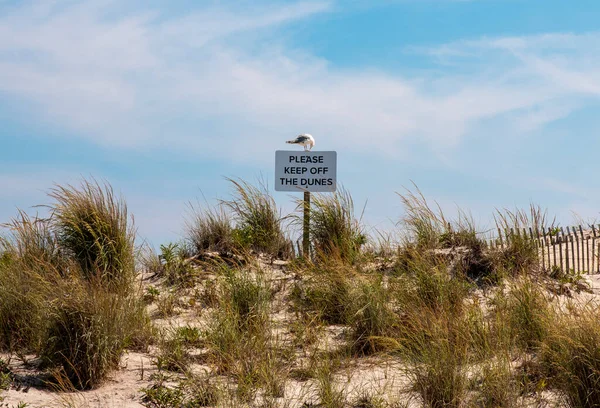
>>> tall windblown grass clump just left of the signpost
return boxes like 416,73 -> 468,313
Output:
222,179 -> 291,257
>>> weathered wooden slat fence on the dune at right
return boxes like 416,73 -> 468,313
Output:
487,225 -> 600,273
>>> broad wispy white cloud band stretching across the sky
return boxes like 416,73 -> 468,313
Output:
0,0 -> 600,163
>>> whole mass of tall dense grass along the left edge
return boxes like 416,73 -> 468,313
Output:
0,181 -> 152,389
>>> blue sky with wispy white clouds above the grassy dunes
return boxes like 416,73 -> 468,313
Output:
0,0 -> 600,245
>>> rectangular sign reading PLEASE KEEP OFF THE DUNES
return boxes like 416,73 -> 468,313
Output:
275,150 -> 337,193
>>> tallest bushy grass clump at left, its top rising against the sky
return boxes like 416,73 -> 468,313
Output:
50,180 -> 135,290
